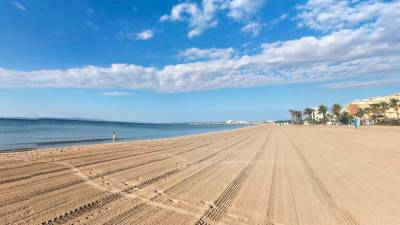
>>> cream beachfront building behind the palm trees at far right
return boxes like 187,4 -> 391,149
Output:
344,92 -> 400,119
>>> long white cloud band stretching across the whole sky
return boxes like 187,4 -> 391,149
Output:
0,0 -> 400,92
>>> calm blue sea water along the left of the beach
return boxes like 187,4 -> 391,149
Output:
0,119 -> 244,150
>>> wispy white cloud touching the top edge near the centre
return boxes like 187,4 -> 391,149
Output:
160,0 -> 264,38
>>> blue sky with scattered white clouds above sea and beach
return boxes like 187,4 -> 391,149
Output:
0,0 -> 400,122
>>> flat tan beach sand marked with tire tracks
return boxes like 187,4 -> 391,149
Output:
0,126 -> 400,225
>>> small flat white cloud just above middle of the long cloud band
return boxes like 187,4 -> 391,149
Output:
178,48 -> 235,61
